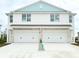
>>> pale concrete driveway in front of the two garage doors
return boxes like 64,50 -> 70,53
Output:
0,43 -> 79,58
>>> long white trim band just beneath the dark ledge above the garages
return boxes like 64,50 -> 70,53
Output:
9,26 -> 71,29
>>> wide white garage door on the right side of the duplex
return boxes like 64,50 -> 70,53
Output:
42,30 -> 68,42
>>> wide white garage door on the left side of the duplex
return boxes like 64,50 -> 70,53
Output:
14,30 -> 39,42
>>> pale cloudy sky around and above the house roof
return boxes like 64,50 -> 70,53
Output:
0,0 -> 79,36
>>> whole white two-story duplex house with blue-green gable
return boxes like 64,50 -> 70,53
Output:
7,1 -> 75,43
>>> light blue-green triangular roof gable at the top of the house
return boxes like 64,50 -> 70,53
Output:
15,1 -> 66,12
